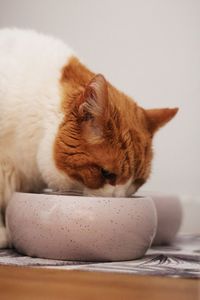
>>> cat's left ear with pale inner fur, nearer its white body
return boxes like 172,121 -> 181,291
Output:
78,74 -> 108,121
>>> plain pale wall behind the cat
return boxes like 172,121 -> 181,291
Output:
0,0 -> 200,195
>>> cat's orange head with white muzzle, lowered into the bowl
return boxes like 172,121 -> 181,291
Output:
54,58 -> 178,197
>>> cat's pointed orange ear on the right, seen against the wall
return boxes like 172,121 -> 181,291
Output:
145,108 -> 178,135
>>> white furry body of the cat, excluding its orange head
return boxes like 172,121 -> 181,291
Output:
0,29 -> 76,244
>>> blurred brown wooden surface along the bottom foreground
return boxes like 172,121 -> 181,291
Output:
0,266 -> 200,300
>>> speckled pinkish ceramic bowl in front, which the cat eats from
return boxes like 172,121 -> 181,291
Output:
6,193 -> 157,261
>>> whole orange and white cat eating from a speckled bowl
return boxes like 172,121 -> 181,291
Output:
0,29 -> 178,247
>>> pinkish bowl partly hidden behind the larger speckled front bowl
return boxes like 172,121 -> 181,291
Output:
140,192 -> 183,245
